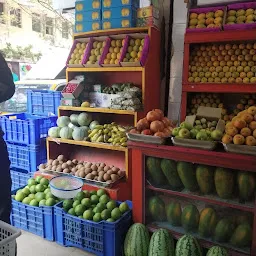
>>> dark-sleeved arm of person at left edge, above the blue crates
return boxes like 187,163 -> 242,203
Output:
0,53 -> 15,103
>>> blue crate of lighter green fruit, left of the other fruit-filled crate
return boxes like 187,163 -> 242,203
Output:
10,187 -> 54,241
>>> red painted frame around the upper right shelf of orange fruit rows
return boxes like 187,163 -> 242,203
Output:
181,29 -> 256,120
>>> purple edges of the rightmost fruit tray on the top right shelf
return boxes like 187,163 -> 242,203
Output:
223,2 -> 256,30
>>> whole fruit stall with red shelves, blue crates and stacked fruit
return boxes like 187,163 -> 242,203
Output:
1,0 -> 256,256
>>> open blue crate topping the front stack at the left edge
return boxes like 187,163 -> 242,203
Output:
0,113 -> 57,145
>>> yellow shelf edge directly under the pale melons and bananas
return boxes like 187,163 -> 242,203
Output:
47,137 -> 128,152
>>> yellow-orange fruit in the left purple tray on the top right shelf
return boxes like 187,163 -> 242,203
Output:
189,10 -> 224,28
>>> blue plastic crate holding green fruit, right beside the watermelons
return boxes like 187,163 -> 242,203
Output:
54,201 -> 132,256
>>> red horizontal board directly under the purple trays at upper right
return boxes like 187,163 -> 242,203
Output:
185,29 -> 256,44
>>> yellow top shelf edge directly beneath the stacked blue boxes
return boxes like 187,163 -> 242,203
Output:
74,27 -> 150,39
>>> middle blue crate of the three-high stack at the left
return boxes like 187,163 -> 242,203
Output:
6,140 -> 47,172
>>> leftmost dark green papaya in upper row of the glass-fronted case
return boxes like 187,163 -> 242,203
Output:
146,157 -> 166,185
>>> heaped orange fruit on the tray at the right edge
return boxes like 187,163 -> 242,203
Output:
222,106 -> 256,146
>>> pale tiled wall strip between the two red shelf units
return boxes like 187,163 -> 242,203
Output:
168,0 -> 187,120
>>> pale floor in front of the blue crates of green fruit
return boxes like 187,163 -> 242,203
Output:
17,231 -> 94,256
